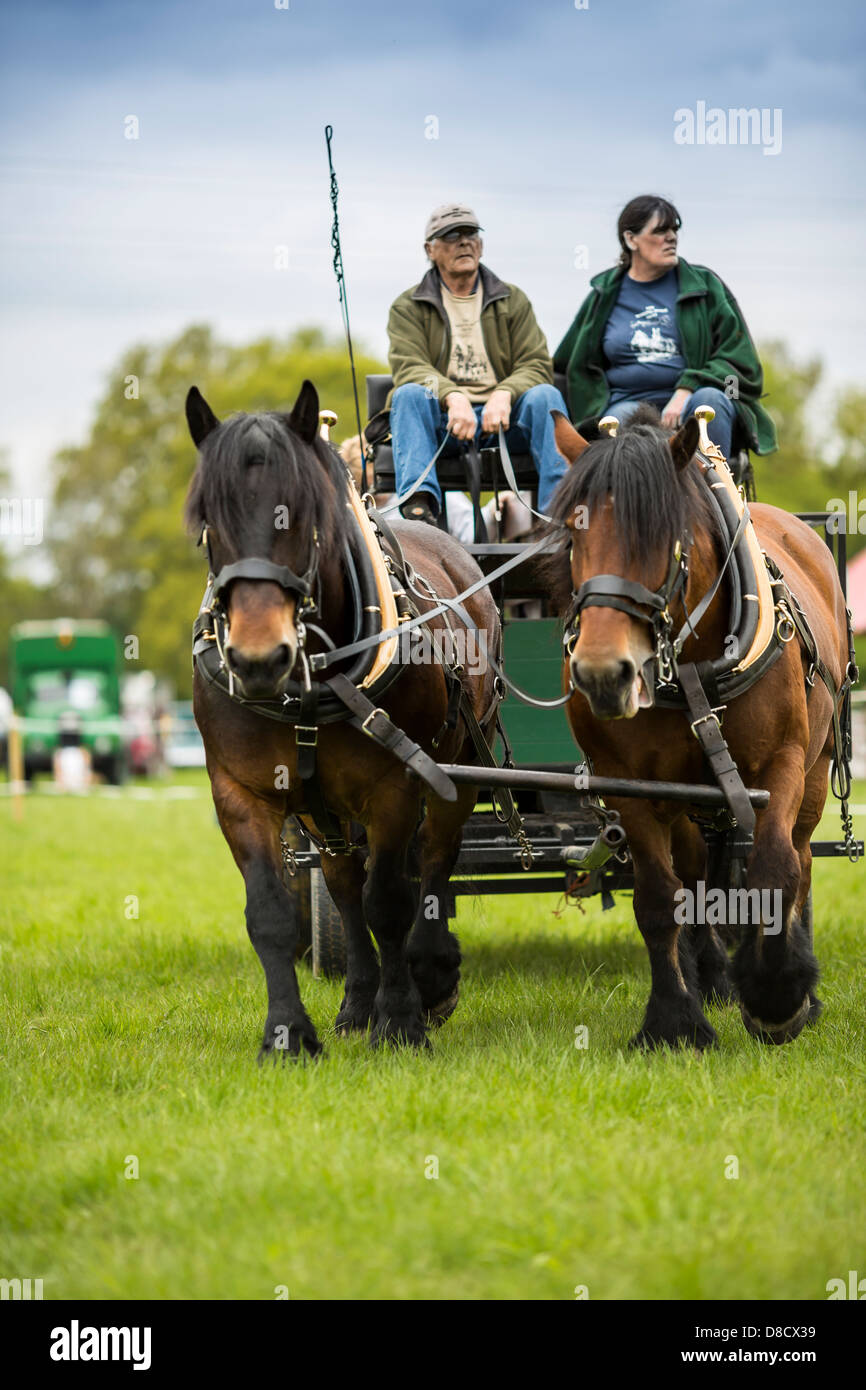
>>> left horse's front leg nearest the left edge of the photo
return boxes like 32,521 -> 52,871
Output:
211,770 -> 321,1062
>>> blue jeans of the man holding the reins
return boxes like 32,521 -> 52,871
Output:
391,382 -> 569,512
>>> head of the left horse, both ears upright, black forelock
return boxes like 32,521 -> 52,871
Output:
186,381 -> 345,699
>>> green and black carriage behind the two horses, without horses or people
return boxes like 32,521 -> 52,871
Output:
286,375 -> 862,976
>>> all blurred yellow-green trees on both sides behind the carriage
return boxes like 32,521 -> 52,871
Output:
0,325 -> 866,698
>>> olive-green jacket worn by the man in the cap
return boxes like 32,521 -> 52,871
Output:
388,265 -> 553,407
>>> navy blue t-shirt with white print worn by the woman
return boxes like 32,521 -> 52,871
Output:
602,267 -> 685,404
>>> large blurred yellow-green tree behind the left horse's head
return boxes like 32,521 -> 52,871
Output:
38,325 -> 384,695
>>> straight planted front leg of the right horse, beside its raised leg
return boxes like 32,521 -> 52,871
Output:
617,802 -> 717,1048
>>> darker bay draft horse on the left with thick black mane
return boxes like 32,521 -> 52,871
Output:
186,381 -> 499,1061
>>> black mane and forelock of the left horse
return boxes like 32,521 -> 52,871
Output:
185,410 -> 346,555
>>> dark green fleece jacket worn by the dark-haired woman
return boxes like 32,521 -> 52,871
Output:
553,260 -> 778,453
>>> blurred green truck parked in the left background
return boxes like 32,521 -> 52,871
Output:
10,619 -> 126,785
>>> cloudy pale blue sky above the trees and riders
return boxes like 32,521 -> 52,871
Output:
0,0 -> 866,511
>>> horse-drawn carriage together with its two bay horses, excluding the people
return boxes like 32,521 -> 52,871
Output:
188,378 -> 862,1055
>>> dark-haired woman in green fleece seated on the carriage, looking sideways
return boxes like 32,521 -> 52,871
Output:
553,196 -> 777,459
